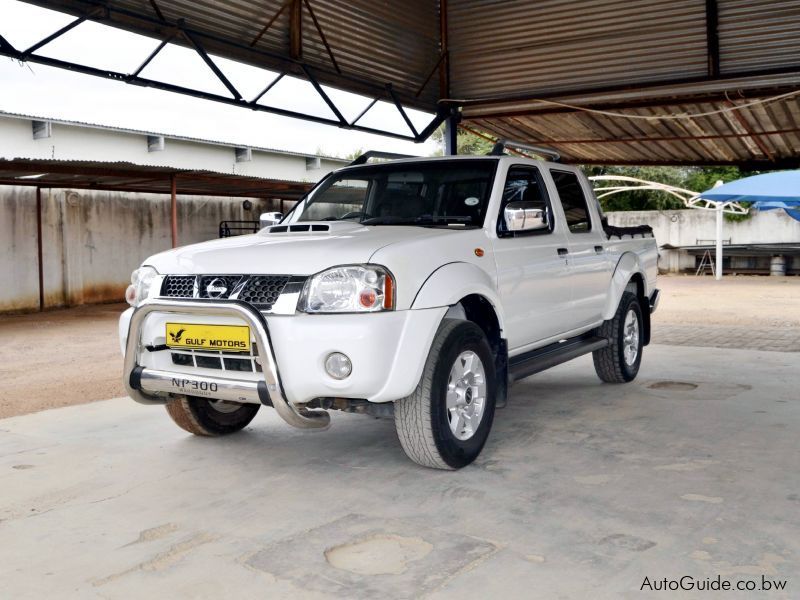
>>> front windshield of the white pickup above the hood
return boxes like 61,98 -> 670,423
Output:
296,160 -> 497,227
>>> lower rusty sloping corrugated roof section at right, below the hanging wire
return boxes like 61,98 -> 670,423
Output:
466,95 -> 800,168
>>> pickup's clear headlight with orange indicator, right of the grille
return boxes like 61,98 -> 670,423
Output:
298,265 -> 395,313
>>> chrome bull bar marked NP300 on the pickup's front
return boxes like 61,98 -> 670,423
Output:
123,298 -> 330,429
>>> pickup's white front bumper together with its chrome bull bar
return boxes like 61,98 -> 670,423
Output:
120,298 -> 447,428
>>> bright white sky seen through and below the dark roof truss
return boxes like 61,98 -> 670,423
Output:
0,0 -> 437,156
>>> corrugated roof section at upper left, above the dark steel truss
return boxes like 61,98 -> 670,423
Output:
23,0 -> 440,110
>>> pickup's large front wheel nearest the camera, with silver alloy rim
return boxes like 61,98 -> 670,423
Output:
394,319 -> 497,470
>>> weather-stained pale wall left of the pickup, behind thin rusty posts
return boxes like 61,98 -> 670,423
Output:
0,186 -> 276,312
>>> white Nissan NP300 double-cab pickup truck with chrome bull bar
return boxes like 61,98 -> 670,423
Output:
119,148 -> 658,469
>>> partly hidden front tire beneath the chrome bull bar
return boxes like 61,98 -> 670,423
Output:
166,396 -> 260,436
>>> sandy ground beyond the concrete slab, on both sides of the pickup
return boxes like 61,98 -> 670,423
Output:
0,276 -> 800,419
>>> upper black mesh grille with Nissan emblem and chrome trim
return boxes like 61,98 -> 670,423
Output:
161,275 -> 294,311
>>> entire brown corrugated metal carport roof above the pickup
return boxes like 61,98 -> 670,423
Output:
12,0 -> 800,168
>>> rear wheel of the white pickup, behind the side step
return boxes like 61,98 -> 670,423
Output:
592,292 -> 644,383
